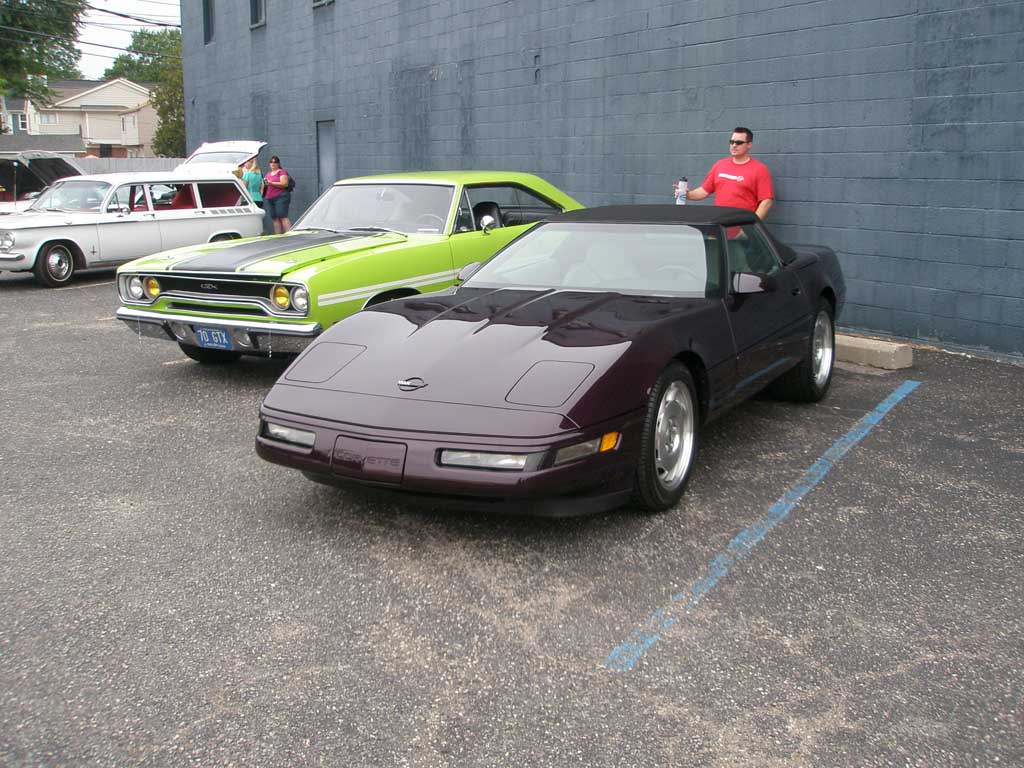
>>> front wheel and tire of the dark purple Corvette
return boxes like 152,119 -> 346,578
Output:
633,362 -> 700,512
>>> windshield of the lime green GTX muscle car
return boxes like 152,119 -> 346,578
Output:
295,183 -> 455,234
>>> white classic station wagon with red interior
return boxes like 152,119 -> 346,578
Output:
0,166 -> 263,288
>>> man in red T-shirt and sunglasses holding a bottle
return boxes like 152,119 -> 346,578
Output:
686,128 -> 775,219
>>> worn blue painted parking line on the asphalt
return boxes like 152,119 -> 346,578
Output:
603,380 -> 921,672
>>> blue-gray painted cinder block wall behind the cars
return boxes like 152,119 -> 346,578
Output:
182,0 -> 1024,354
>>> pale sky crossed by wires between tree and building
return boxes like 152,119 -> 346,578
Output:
78,0 -> 181,80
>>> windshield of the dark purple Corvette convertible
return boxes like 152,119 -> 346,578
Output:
465,222 -> 720,296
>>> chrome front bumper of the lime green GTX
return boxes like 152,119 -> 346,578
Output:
117,306 -> 324,356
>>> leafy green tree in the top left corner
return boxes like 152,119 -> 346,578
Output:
0,0 -> 87,103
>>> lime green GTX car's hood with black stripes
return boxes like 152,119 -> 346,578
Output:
118,229 -> 411,275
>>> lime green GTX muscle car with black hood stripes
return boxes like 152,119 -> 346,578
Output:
117,171 -> 582,364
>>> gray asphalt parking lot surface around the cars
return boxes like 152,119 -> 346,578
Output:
0,273 -> 1024,768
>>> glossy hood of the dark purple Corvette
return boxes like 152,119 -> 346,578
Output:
268,289 -> 708,426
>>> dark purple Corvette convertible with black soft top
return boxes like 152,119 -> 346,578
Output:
256,206 -> 846,515
